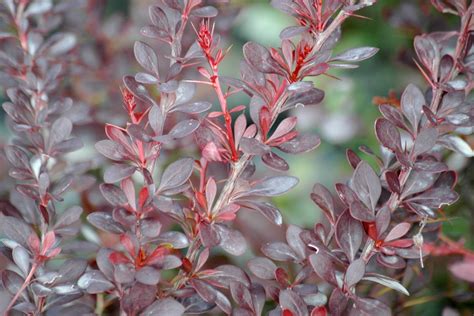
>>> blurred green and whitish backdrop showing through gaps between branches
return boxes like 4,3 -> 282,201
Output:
0,0 -> 474,315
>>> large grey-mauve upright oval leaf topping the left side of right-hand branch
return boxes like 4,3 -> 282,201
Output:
352,161 -> 382,210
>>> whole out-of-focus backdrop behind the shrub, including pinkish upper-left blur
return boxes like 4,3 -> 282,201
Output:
0,0 -> 474,315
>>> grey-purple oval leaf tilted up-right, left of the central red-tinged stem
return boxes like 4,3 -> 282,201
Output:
158,158 -> 194,192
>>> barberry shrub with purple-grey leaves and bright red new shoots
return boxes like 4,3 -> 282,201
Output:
0,0 -> 474,316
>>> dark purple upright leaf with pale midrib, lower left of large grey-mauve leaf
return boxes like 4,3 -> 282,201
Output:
336,211 -> 364,262
